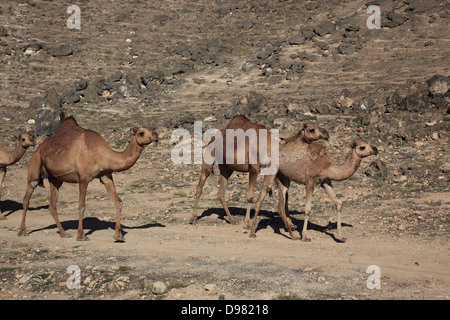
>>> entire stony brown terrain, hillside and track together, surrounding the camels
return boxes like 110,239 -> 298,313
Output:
0,0 -> 450,300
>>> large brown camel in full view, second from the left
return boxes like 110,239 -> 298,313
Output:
18,117 -> 158,241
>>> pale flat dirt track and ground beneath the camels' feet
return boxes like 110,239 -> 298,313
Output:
0,147 -> 450,299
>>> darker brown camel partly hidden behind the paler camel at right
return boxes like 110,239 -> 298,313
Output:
190,115 -> 328,229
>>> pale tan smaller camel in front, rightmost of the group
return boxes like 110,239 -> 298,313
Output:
250,140 -> 378,242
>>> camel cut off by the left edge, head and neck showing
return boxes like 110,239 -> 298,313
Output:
0,133 -> 35,220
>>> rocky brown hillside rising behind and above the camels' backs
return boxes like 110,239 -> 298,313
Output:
0,0 -> 450,188
